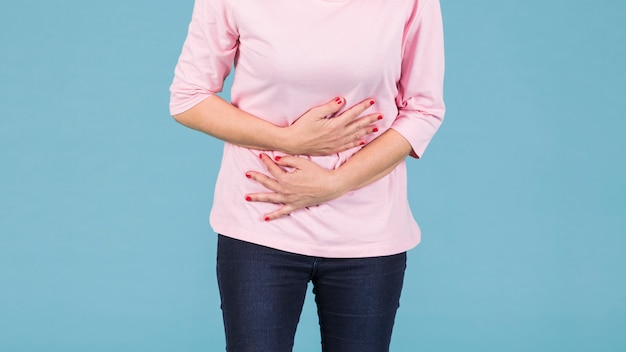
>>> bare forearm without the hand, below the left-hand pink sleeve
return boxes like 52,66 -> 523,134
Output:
174,95 -> 289,153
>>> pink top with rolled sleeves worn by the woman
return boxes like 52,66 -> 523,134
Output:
170,0 -> 445,258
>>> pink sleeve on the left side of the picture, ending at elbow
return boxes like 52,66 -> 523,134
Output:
170,0 -> 239,115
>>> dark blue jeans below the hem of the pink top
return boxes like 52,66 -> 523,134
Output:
217,235 -> 406,352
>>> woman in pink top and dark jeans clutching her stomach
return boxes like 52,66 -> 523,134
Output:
170,0 -> 444,352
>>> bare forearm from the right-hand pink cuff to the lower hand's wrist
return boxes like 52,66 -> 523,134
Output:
334,129 -> 412,193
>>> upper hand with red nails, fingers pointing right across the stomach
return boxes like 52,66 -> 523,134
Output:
285,97 -> 383,156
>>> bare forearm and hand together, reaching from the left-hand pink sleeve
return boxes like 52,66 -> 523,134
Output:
174,95 -> 383,156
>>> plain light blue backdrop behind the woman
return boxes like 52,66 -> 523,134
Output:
0,0 -> 626,352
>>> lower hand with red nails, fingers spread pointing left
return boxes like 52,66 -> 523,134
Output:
246,153 -> 346,221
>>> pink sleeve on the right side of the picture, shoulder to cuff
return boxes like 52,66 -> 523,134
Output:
391,0 -> 445,158
